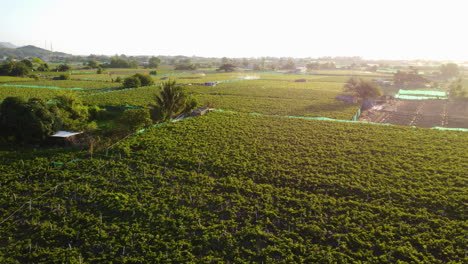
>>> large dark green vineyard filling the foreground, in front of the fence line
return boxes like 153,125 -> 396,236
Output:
0,112 -> 468,263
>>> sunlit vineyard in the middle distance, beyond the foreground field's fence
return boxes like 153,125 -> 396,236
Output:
0,73 -> 359,120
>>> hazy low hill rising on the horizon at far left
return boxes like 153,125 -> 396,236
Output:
0,42 -> 73,59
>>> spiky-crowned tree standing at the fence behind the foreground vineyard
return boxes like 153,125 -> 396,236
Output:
151,81 -> 197,122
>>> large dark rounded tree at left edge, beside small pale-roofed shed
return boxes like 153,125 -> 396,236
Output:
0,97 -> 62,143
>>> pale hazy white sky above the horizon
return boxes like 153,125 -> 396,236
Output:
0,0 -> 468,60
